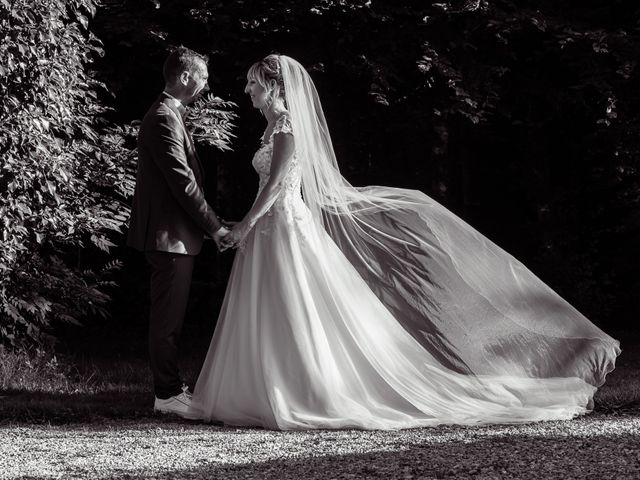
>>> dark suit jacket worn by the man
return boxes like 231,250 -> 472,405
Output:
127,93 -> 220,255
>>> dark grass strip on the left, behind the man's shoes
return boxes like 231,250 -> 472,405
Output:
0,356 -> 200,425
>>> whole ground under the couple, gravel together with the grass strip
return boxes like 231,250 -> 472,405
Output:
0,334 -> 640,480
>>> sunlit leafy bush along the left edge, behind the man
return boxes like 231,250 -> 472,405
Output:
0,0 -> 134,344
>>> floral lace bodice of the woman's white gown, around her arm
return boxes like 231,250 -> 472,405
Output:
251,114 -> 302,212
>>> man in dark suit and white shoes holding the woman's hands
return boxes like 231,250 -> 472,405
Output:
127,47 -> 228,418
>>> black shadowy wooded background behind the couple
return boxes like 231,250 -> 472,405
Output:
60,0 -> 640,355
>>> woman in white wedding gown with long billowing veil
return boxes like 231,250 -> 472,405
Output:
191,55 -> 620,430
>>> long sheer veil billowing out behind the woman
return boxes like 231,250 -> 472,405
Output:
279,55 -> 620,386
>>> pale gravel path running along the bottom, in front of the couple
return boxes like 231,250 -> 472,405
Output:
0,414 -> 640,480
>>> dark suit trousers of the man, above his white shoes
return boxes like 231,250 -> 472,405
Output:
145,251 -> 194,399
